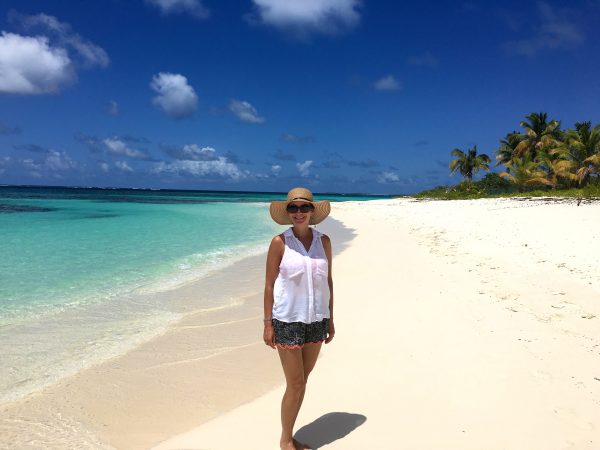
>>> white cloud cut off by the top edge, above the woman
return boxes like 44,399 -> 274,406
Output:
250,0 -> 362,37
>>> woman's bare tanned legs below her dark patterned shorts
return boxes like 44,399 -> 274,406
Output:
278,343 -> 321,450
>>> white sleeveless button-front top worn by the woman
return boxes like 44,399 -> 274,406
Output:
273,228 -> 330,323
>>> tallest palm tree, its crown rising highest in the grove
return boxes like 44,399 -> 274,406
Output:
515,112 -> 560,161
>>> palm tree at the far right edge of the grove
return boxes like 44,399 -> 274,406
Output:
565,122 -> 600,187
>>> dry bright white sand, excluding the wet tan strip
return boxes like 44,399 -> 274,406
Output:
154,199 -> 600,450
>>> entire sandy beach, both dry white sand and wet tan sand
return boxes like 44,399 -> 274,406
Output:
0,199 -> 600,450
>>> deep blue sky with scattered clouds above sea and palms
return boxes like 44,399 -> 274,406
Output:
0,0 -> 600,193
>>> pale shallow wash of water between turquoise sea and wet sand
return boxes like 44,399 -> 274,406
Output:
0,234 -> 276,407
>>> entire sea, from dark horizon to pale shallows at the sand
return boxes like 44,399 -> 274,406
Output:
0,186 -> 384,402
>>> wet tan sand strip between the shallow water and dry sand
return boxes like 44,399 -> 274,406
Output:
0,214 -> 351,449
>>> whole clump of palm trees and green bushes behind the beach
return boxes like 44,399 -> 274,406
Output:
417,112 -> 600,200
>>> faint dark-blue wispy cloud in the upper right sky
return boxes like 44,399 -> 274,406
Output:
504,1 -> 585,56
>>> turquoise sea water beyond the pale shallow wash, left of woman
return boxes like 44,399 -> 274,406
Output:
0,193 -> 276,324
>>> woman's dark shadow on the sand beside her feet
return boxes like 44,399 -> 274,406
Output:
294,412 -> 367,450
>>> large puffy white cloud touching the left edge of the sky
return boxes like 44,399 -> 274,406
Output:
0,31 -> 76,95
